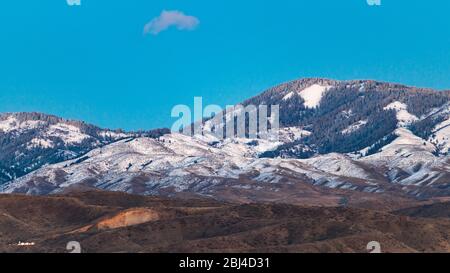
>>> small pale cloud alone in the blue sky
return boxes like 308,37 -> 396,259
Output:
144,10 -> 200,35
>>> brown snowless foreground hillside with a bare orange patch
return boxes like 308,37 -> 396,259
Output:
0,191 -> 450,253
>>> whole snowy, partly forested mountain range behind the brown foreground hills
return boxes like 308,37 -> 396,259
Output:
0,78 -> 450,209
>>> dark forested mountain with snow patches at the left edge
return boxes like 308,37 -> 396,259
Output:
0,113 -> 149,184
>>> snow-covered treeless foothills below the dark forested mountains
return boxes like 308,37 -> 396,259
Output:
0,122 -> 448,198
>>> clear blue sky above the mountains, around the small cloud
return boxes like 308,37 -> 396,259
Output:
0,0 -> 450,130
